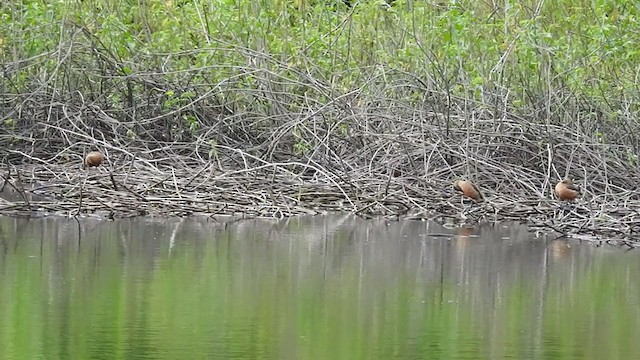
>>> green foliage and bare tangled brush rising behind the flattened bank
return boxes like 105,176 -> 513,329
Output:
0,0 -> 640,238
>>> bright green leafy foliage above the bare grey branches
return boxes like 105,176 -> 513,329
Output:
0,0 -> 640,136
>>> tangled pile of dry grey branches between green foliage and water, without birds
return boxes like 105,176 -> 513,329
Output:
0,107 -> 640,246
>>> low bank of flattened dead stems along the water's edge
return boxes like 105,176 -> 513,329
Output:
0,150 -> 640,248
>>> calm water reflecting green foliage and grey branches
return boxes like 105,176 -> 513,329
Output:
0,216 -> 640,359
